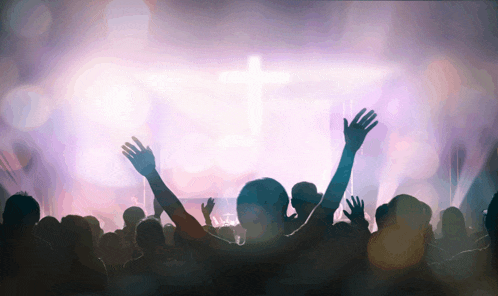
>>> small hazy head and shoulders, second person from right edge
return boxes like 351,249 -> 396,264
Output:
436,207 -> 474,257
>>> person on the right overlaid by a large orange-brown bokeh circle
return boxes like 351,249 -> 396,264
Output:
368,194 -> 449,295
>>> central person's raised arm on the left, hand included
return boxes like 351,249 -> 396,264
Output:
121,137 -> 206,238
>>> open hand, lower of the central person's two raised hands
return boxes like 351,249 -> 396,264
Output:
121,137 -> 156,177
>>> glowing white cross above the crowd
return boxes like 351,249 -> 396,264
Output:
220,56 -> 290,135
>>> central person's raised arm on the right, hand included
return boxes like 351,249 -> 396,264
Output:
322,109 -> 378,217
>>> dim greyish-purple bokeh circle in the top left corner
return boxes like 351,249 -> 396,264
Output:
3,0 -> 52,38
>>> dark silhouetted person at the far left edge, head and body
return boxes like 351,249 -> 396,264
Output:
0,192 -> 58,295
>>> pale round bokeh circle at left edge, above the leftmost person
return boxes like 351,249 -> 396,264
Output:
0,85 -> 53,131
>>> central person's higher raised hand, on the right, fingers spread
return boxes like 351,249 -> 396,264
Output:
344,109 -> 378,152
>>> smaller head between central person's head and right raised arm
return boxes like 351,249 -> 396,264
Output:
291,182 -> 322,219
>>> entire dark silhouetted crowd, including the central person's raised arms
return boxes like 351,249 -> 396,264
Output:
0,109 -> 498,296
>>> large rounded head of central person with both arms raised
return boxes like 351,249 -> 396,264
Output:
237,178 -> 289,242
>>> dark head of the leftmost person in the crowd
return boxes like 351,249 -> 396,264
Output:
2,192 -> 40,233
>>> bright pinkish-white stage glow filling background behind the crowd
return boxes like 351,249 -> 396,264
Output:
0,0 -> 498,229
